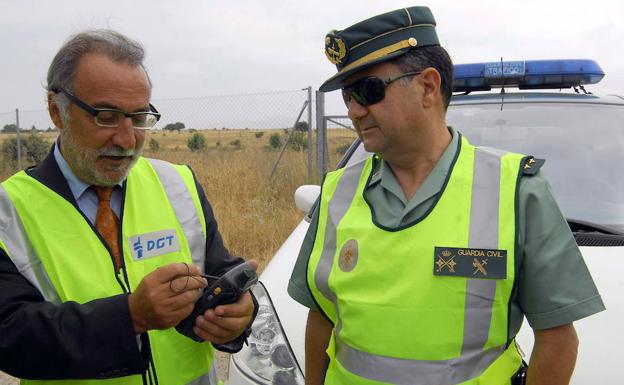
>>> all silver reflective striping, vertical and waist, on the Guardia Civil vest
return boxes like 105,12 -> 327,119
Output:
315,148 -> 505,385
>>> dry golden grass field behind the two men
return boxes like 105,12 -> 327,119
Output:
0,130 -> 355,268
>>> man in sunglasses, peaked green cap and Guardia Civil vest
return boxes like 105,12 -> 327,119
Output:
288,7 -> 604,385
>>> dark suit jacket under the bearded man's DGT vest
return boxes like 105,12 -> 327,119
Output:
0,152 -> 244,379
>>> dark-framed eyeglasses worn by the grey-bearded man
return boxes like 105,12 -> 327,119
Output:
52,88 -> 160,130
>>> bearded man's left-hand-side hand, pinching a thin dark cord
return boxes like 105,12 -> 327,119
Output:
128,263 -> 208,334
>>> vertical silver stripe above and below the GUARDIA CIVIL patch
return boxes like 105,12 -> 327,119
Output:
462,147 -> 505,356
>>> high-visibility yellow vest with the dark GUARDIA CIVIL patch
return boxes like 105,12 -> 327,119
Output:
307,138 -> 524,385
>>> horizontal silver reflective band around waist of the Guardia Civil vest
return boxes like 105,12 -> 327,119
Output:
334,335 -> 505,385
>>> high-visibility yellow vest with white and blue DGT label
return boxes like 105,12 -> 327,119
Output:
0,158 -> 214,385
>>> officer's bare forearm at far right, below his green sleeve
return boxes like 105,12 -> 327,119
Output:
527,323 -> 578,385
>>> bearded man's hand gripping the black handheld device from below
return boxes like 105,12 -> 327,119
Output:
193,259 -> 258,344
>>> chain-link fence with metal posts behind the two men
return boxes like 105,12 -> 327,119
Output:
0,87 -> 357,180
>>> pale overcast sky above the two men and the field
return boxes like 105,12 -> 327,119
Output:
0,0 -> 624,127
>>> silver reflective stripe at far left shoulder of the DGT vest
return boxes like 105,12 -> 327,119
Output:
0,186 -> 61,304
